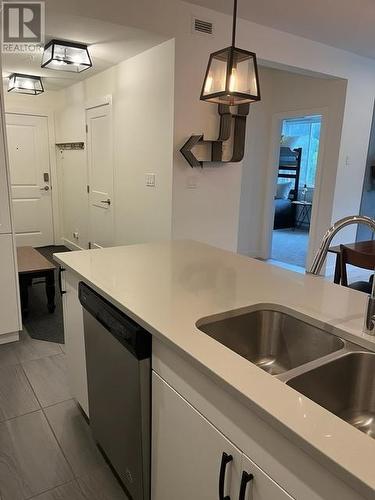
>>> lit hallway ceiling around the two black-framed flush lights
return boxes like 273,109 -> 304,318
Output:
2,14 -> 163,90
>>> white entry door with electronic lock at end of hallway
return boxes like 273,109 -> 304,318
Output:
6,113 -> 54,247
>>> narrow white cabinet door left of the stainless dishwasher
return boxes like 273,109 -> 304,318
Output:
62,271 -> 89,416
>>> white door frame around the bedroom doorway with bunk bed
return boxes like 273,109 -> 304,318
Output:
260,107 -> 330,268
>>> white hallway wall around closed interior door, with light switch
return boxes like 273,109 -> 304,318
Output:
56,41 -> 174,248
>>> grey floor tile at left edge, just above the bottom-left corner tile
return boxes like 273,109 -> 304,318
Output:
0,365 -> 40,421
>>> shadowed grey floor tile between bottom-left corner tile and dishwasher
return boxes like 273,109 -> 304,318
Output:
44,400 -> 105,476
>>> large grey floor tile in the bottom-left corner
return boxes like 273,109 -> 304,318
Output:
0,411 -> 73,500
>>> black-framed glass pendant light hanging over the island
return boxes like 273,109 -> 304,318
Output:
200,0 -> 260,106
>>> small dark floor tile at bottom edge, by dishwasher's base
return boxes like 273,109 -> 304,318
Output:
77,466 -> 128,500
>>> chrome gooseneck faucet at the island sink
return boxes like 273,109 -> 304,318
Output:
307,215 -> 375,335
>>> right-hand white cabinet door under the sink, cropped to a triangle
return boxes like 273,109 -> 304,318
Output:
239,455 -> 293,500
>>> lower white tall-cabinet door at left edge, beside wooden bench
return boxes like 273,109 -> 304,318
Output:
0,234 -> 20,336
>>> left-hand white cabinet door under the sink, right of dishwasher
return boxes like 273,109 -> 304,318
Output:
152,372 -> 242,500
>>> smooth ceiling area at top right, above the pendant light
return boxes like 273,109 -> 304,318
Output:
189,0 -> 375,59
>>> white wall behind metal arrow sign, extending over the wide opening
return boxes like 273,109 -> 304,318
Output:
9,0 -> 375,254
